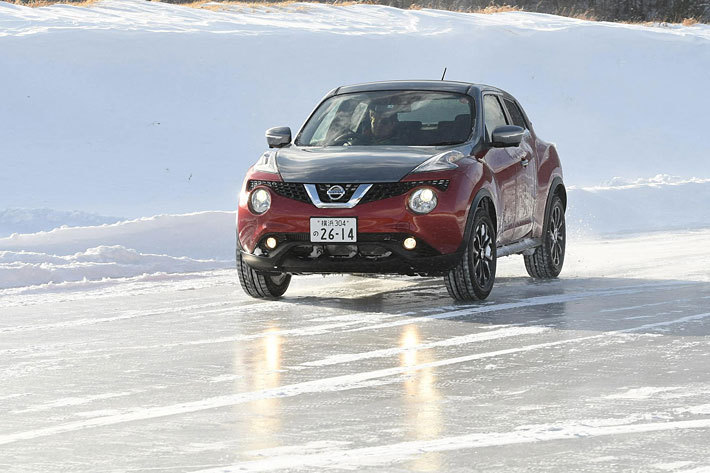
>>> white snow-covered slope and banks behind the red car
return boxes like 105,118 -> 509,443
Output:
0,0 -> 710,288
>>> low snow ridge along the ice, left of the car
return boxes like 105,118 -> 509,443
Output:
0,212 -> 236,289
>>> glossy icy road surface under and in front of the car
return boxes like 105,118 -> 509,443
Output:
0,233 -> 710,472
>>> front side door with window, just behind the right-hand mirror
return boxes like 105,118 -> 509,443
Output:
483,94 -> 520,245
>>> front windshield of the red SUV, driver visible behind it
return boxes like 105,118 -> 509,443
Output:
296,91 -> 474,146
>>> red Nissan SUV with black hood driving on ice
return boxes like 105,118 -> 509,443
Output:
237,81 -> 567,301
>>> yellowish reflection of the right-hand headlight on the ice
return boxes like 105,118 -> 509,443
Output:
400,325 -> 443,471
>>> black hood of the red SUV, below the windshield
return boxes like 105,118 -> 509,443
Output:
276,146 -> 442,184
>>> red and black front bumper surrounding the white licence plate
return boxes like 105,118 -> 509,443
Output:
237,172 -> 473,275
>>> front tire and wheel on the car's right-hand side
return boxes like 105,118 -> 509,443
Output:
444,207 -> 496,302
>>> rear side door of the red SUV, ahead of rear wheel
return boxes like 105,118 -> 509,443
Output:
502,97 -> 537,241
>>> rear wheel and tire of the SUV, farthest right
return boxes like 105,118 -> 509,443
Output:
523,195 -> 567,279
